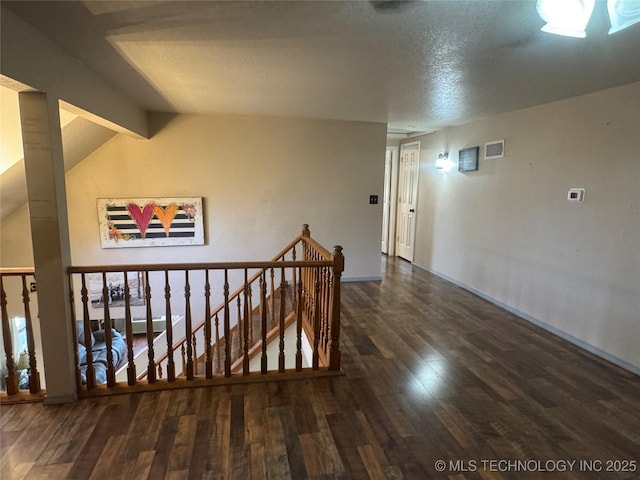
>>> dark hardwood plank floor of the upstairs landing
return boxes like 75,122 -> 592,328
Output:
0,258 -> 640,480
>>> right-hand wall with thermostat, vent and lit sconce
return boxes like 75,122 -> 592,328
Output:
408,83 -> 640,371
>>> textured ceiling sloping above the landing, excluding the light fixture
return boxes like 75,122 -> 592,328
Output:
3,1 -> 640,135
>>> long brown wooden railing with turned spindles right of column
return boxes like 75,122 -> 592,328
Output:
69,225 -> 344,395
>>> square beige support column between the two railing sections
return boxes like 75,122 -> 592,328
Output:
19,92 -> 77,403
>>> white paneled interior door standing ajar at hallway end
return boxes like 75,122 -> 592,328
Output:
396,142 -> 420,262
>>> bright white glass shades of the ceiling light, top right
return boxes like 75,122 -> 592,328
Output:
536,0 -> 640,38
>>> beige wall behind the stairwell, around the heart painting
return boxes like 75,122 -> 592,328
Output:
66,115 -> 386,278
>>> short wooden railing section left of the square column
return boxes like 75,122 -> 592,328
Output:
0,267 -> 44,403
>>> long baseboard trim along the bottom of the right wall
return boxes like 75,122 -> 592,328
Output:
413,263 -> 640,376
